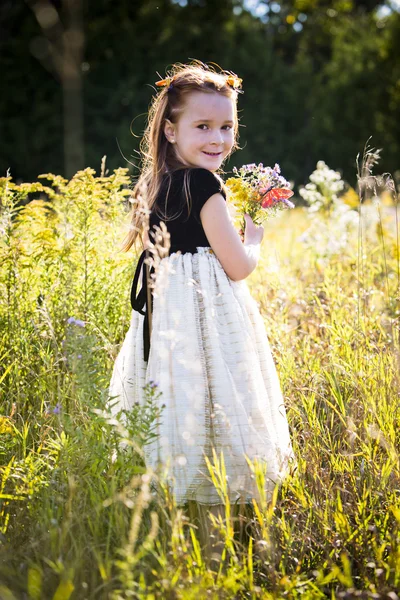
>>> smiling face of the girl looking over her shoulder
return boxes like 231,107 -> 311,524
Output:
164,92 -> 236,171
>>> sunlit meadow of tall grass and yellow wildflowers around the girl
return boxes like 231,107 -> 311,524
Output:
0,161 -> 400,600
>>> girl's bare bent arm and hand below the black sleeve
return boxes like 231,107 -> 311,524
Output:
200,194 -> 264,281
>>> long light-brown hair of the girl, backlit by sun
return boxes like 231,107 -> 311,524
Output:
122,61 -> 241,251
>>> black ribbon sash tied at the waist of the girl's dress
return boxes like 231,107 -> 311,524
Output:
131,246 -> 202,362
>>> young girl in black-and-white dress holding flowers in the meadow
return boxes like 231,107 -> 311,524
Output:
109,62 -> 293,556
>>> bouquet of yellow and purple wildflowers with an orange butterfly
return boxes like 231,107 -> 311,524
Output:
226,163 -> 294,232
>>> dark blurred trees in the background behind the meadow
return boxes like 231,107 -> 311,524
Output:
0,0 -> 400,185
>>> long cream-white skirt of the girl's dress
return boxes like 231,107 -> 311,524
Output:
109,246 -> 295,505
